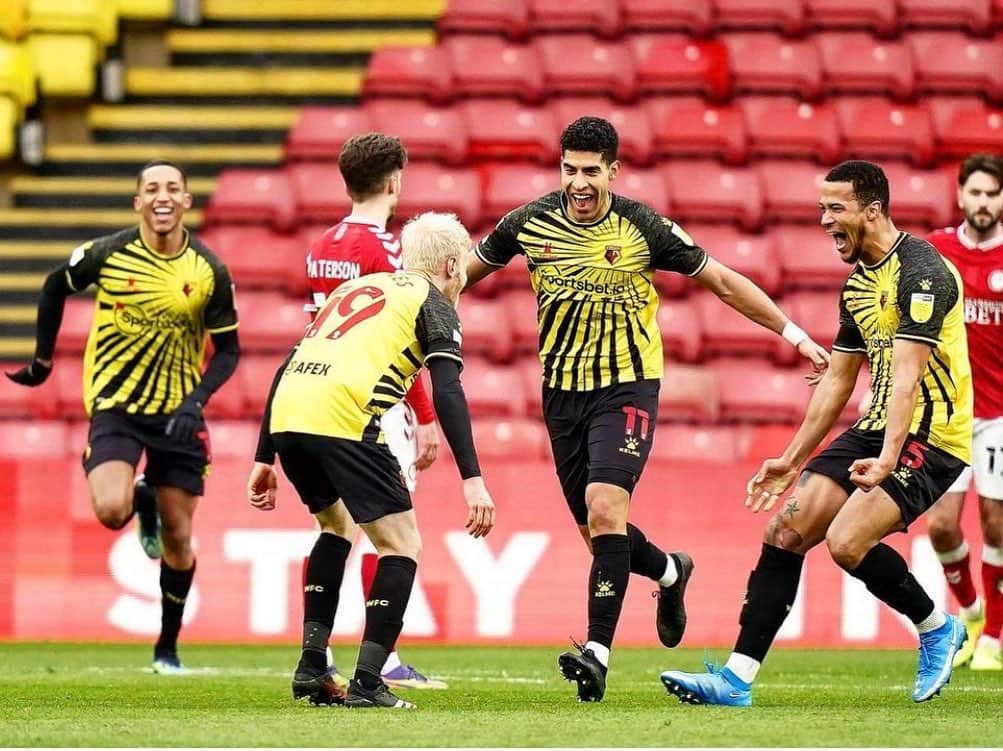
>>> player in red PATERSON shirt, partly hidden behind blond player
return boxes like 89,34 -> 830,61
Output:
303,133 -> 446,689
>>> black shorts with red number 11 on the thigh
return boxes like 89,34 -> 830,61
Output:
544,379 -> 660,525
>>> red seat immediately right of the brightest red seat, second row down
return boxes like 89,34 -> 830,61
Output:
724,34 -> 822,99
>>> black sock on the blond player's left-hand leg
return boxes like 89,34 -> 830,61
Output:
300,532 -> 352,671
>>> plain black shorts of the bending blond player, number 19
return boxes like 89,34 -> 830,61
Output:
272,432 -> 412,524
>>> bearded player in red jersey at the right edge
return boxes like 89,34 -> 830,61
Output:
927,153 -> 1003,670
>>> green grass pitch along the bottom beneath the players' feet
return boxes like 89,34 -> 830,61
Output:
0,644 -> 1003,747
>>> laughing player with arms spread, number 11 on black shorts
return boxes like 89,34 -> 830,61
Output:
467,117 -> 828,701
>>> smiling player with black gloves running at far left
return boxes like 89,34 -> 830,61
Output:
7,160 -> 240,674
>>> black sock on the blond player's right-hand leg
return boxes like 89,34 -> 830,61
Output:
355,555 -> 418,688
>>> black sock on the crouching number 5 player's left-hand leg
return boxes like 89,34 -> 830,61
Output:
735,542 -> 804,663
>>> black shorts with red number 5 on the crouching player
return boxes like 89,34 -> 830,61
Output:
804,428 -> 968,531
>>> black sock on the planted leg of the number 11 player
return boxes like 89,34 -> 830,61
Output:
588,534 -> 630,647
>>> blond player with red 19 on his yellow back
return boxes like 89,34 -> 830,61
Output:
248,214 -> 494,709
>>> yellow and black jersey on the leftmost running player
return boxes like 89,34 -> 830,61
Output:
66,228 -> 237,415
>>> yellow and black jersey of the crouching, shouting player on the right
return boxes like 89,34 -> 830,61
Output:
832,233 -> 973,464
